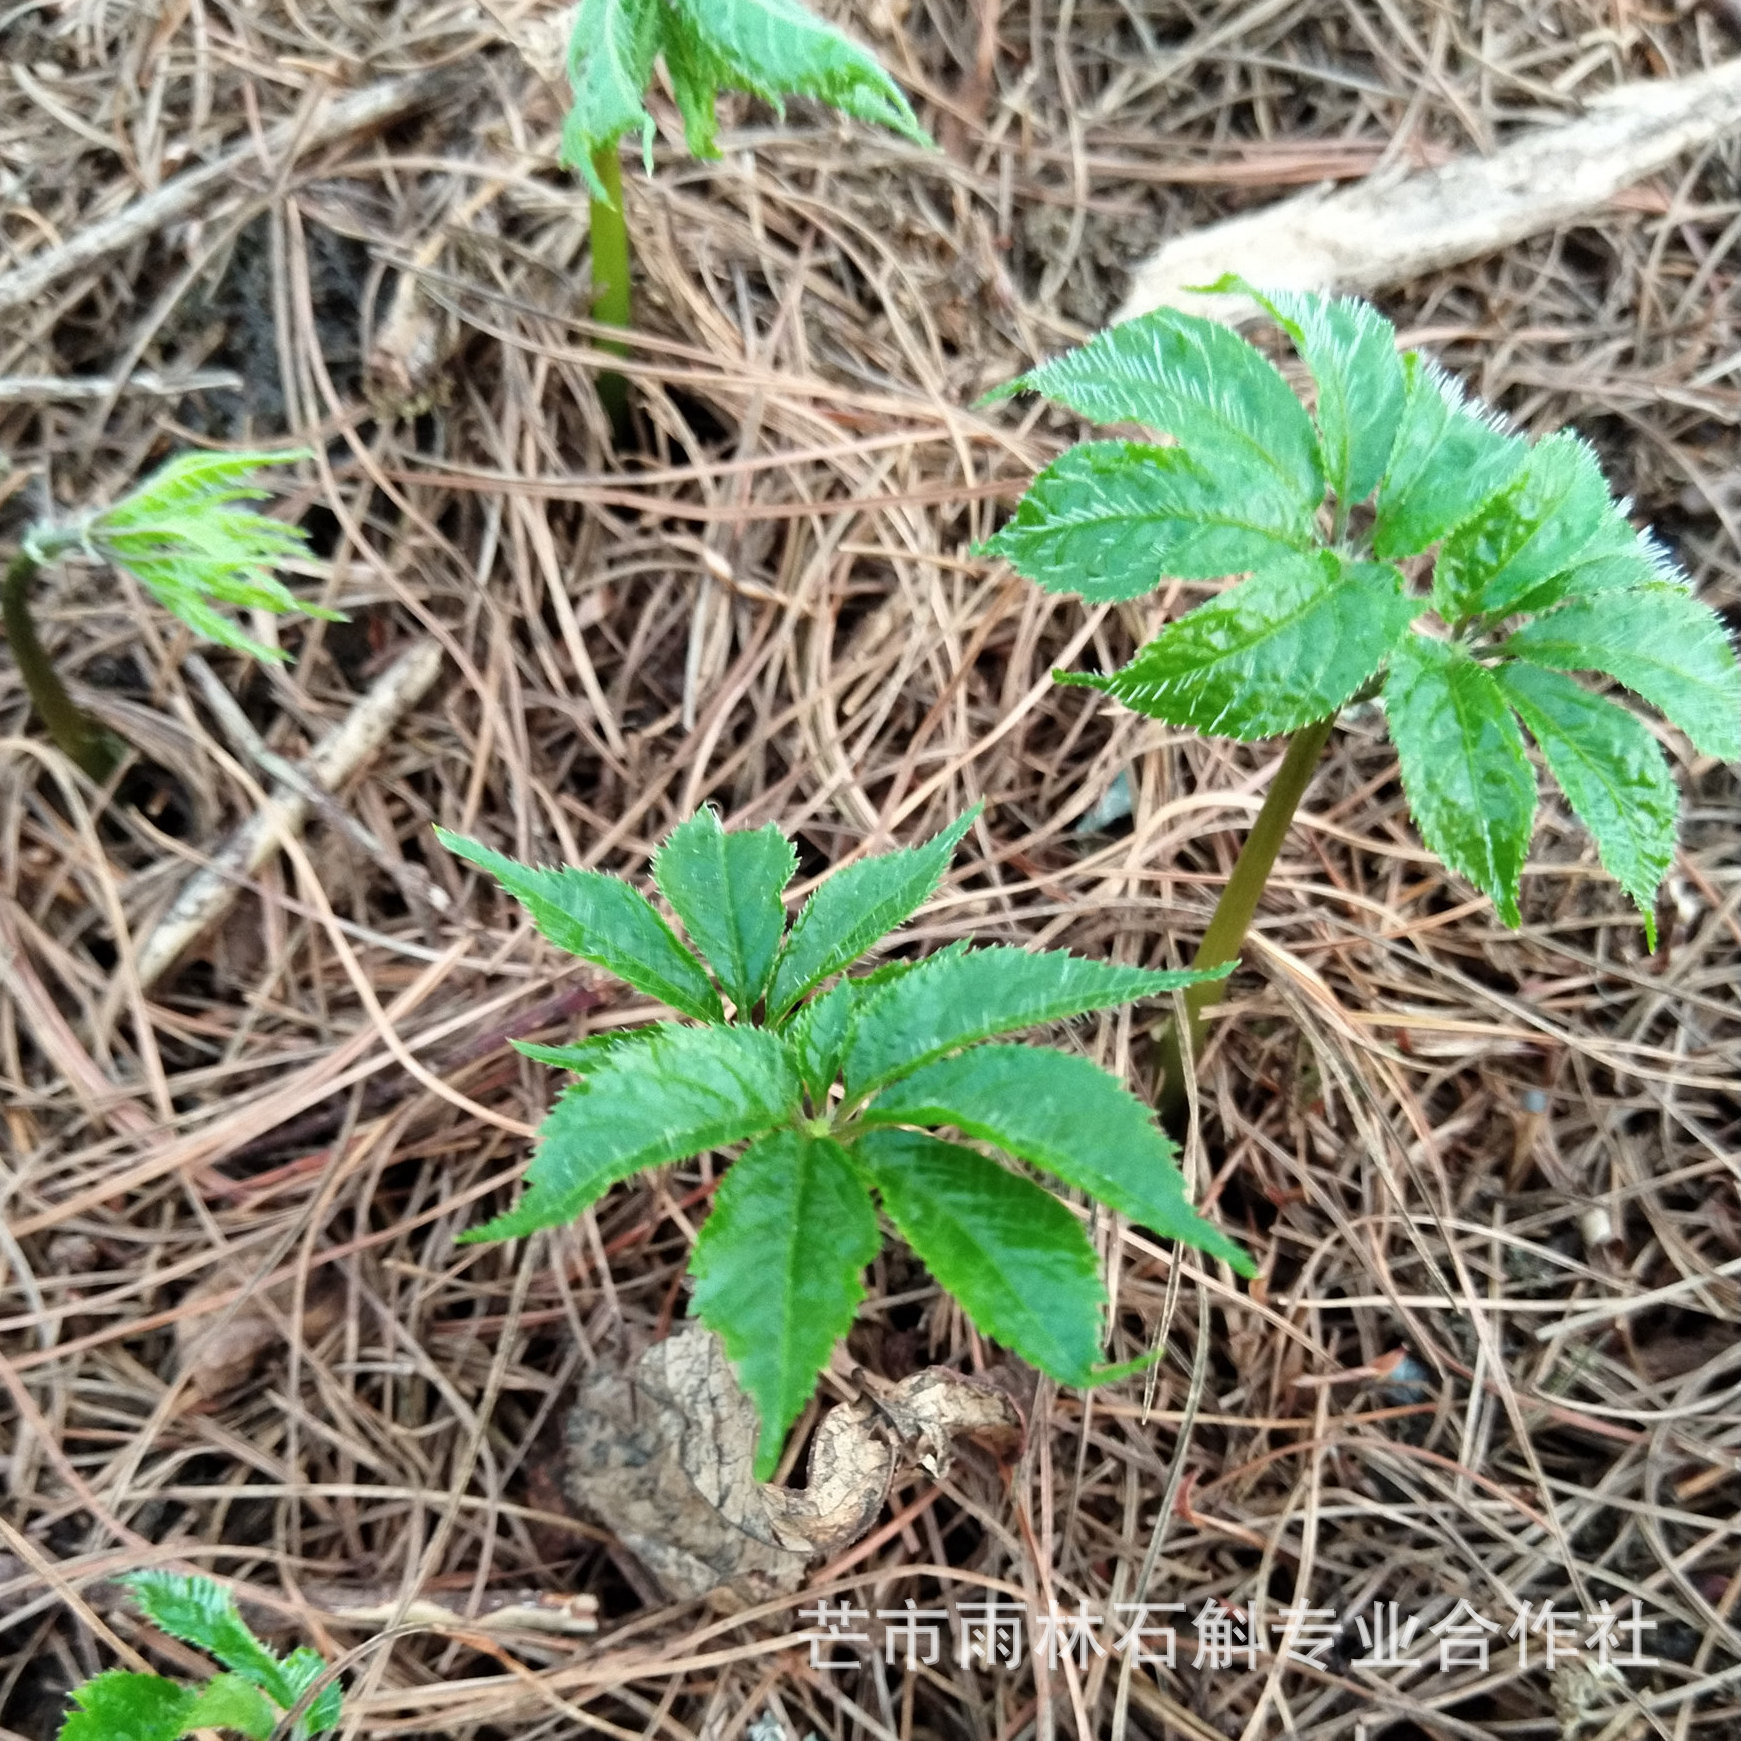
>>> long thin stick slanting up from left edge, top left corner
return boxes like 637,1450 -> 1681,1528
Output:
0,68 -> 463,315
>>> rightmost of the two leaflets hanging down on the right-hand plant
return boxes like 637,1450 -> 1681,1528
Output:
1494,660 -> 1680,949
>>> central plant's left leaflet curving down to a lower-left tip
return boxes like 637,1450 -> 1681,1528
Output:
460,1022 -> 799,1243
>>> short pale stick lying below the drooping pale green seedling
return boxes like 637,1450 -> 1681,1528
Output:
139,641 -> 440,985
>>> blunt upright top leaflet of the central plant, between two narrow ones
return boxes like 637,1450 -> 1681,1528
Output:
653,806 -> 797,1020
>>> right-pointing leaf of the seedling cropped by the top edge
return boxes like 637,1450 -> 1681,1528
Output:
667,0 -> 931,146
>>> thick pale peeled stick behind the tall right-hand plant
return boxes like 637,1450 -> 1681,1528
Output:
1118,59 -> 1741,322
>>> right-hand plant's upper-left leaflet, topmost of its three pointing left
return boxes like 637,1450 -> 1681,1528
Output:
987,308 -> 1323,514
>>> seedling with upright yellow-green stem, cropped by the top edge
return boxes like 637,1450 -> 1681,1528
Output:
561,0 -> 931,434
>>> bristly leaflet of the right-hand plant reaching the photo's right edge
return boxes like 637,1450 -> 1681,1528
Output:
1501,587 -> 1741,761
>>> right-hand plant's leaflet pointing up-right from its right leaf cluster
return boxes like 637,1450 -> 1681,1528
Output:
1433,430 -> 1610,623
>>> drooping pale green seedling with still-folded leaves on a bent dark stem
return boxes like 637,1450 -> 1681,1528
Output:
3,453 -> 330,783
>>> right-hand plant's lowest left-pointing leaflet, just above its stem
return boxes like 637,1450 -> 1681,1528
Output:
1055,550 -> 1419,742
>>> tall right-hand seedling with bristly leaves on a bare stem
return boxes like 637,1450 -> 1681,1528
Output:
984,277 -> 1741,1130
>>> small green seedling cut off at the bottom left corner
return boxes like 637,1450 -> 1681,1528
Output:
59,1572 -> 343,1741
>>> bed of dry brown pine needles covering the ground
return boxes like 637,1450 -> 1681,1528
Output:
0,0 -> 1741,1741
